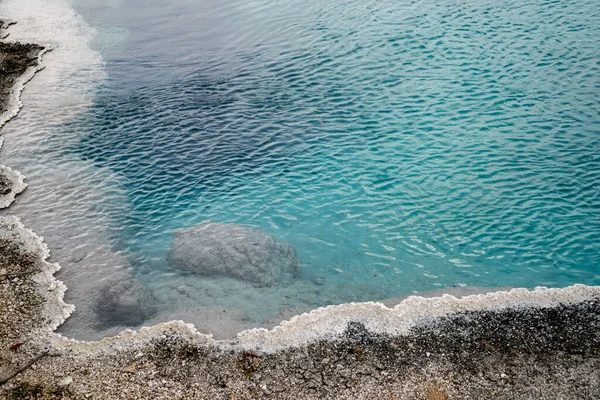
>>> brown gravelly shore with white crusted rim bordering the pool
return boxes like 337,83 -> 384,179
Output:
0,16 -> 600,400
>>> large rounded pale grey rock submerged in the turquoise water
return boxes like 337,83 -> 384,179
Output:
168,222 -> 300,286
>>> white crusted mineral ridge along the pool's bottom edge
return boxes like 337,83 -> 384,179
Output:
44,285 -> 600,353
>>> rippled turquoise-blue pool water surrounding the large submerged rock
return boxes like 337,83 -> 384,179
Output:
1,0 -> 600,338
